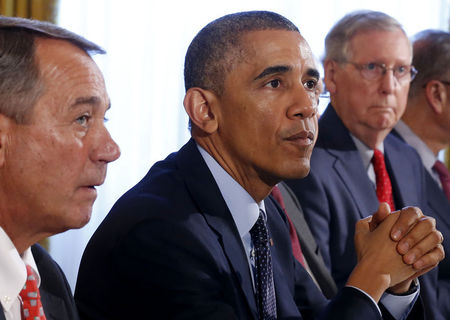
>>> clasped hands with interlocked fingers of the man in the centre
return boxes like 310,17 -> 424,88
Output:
347,203 -> 445,302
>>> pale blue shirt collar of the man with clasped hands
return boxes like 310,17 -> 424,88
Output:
197,144 -> 265,238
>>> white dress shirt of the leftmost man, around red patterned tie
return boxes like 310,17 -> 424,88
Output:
0,227 -> 41,320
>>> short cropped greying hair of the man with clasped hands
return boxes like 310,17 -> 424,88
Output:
184,11 -> 299,95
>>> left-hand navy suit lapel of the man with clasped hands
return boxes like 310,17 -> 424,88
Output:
177,139 -> 257,317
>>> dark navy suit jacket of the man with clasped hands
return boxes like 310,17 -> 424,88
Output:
75,140 -> 379,320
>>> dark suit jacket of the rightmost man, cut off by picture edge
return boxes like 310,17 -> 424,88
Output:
392,130 -> 450,319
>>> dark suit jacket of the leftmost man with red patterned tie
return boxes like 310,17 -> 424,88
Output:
0,244 -> 79,320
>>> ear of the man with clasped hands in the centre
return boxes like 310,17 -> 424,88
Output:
183,87 -> 218,134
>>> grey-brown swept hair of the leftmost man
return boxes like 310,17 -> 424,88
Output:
0,16 -> 105,123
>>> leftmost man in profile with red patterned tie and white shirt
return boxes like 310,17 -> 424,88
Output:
0,17 -> 119,320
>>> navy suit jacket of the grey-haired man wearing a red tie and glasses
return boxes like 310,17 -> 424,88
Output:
287,105 -> 439,319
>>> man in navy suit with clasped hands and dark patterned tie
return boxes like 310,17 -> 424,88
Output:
75,11 -> 443,319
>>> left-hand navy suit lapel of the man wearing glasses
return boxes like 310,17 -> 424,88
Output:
318,105 -> 378,218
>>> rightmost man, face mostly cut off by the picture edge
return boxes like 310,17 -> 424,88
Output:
393,30 -> 450,318
